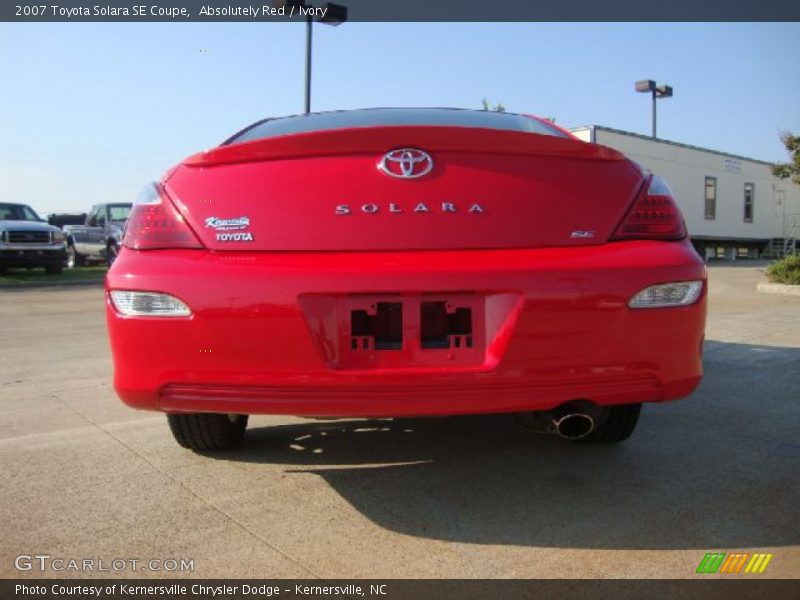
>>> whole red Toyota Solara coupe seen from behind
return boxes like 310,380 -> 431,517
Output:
106,108 -> 706,451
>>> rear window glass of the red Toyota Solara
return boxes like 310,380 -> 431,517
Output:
225,108 -> 567,144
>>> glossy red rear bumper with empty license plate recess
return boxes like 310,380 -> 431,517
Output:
106,242 -> 706,416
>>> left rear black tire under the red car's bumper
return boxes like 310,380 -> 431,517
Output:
167,413 -> 247,452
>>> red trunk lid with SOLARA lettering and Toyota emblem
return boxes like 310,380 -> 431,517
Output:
164,126 -> 644,251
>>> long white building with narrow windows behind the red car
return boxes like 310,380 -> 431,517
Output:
572,125 -> 800,259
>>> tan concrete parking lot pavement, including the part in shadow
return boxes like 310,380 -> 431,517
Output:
0,264 -> 800,578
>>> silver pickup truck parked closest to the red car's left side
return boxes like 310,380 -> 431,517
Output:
64,202 -> 131,266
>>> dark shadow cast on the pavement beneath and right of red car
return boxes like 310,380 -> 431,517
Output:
209,342 -> 800,550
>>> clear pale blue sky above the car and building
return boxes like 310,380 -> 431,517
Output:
0,22 -> 800,215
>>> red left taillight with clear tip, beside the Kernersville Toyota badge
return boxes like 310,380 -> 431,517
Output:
122,183 -> 203,250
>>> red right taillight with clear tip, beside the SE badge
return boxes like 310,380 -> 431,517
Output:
611,175 -> 686,240
